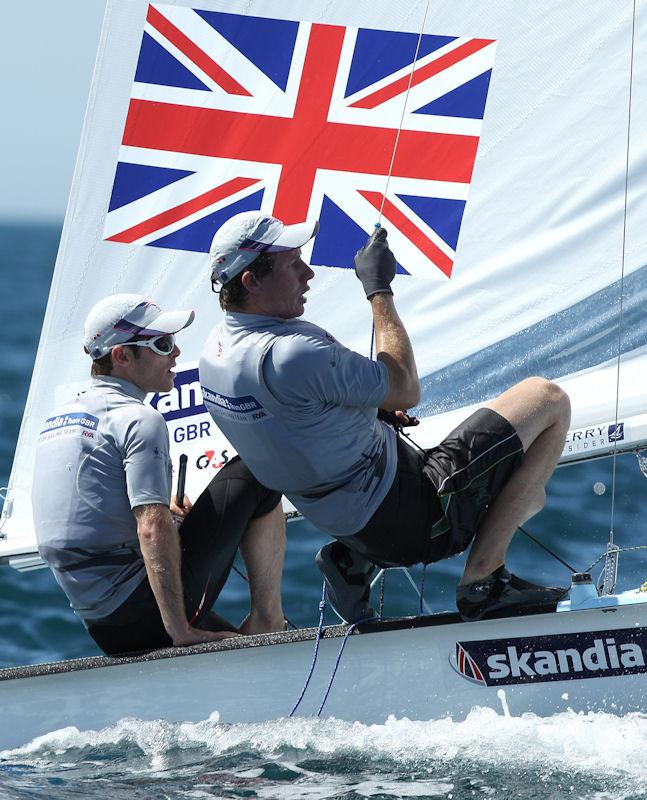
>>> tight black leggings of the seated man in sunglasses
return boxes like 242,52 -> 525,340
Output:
85,456 -> 281,655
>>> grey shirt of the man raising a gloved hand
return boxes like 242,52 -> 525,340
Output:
200,313 -> 397,536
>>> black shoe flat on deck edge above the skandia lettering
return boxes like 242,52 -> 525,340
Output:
456,565 -> 568,622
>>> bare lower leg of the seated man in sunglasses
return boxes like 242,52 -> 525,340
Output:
239,503 -> 285,634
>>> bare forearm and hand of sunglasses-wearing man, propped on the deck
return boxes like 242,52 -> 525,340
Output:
133,503 -> 235,647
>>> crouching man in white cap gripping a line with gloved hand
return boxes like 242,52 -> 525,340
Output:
200,212 -> 570,622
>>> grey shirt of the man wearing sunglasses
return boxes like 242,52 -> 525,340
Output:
32,377 -> 172,619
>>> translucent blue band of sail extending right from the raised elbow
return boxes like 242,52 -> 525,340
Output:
417,266 -> 647,417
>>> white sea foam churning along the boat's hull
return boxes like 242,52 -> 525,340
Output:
0,708 -> 647,780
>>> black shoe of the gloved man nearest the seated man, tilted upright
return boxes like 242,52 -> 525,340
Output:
315,542 -> 375,624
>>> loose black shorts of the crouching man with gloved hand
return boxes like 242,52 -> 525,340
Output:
337,408 -> 523,567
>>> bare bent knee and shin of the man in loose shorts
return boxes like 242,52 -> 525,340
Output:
461,378 -> 570,584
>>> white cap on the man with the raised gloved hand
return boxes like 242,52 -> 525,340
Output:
209,211 -> 319,283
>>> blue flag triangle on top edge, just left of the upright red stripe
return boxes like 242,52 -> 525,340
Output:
195,9 -> 299,91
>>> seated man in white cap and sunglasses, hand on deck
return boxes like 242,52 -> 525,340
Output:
32,294 -> 285,654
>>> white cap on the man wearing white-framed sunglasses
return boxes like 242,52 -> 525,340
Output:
83,294 -> 195,361
